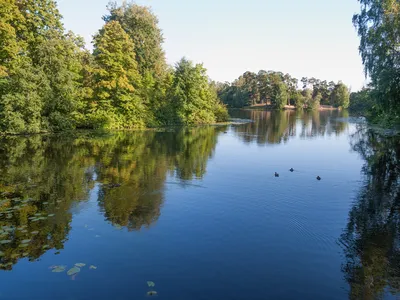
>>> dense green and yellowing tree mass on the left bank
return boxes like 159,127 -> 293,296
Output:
0,0 -> 228,134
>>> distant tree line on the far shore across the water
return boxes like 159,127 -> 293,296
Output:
215,70 -> 350,109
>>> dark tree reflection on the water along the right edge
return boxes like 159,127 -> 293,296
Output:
340,127 -> 400,299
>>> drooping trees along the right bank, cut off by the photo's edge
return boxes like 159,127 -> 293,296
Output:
350,0 -> 400,125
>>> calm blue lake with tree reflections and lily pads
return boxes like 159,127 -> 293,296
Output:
0,111 -> 400,300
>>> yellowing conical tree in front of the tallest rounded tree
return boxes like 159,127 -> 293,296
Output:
89,21 -> 145,128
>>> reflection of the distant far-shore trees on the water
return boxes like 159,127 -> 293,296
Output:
231,110 -> 348,145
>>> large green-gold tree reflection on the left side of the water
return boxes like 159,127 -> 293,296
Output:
0,127 -> 226,270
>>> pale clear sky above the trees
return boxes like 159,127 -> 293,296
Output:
58,0 -> 365,91
